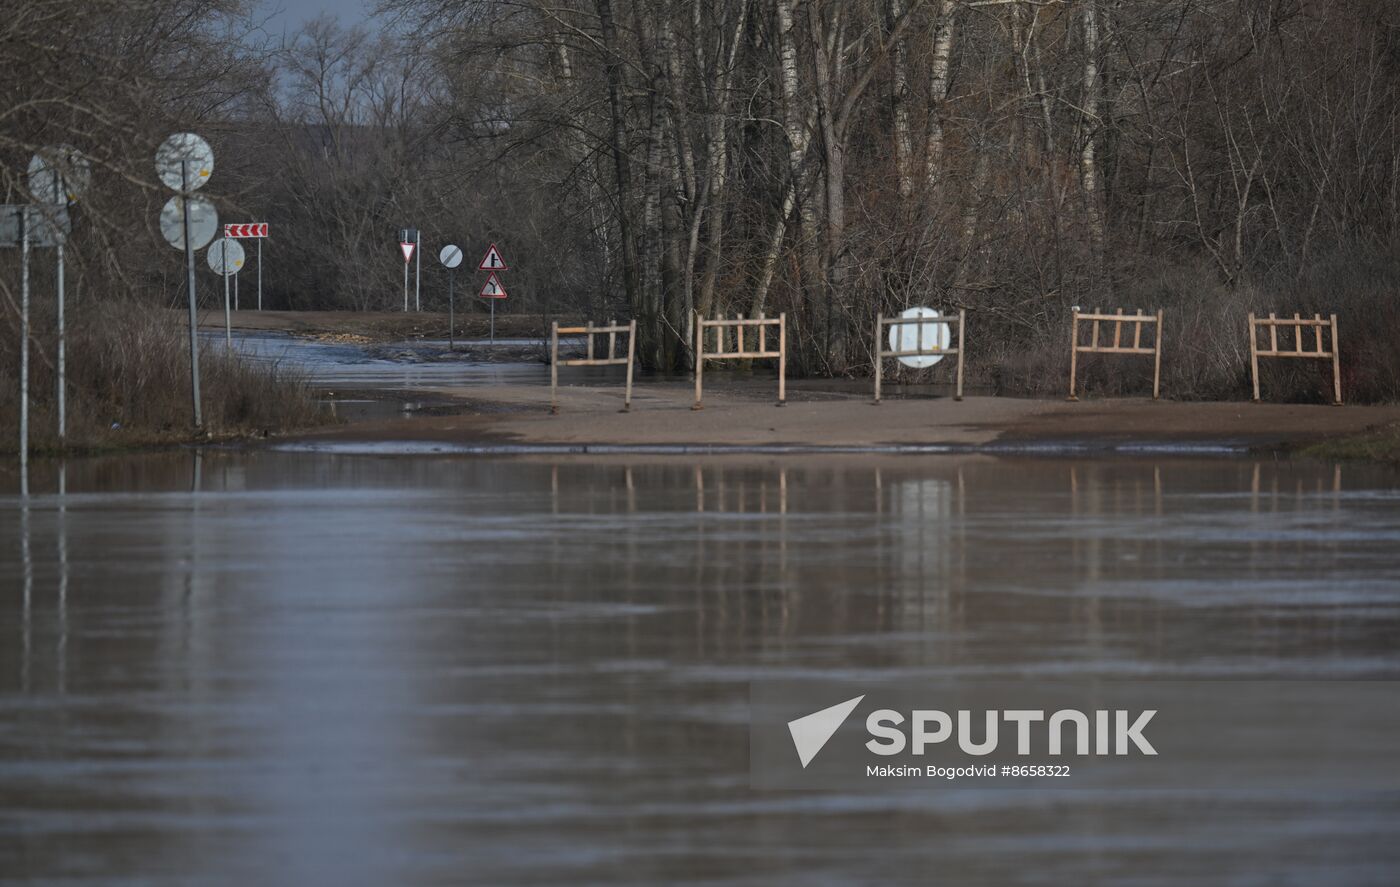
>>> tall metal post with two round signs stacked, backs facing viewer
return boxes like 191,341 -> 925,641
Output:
155,133 -> 218,428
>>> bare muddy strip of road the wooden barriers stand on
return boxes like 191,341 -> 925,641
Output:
287,378 -> 1400,455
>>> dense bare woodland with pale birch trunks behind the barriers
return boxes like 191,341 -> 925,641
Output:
0,0 -> 1400,399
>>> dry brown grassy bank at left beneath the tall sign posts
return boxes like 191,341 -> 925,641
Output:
0,299 -> 329,453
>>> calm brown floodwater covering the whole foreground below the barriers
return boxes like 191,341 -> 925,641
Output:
0,450 -> 1400,886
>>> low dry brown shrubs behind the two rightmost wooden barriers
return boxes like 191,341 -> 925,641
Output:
967,250 -> 1400,403
